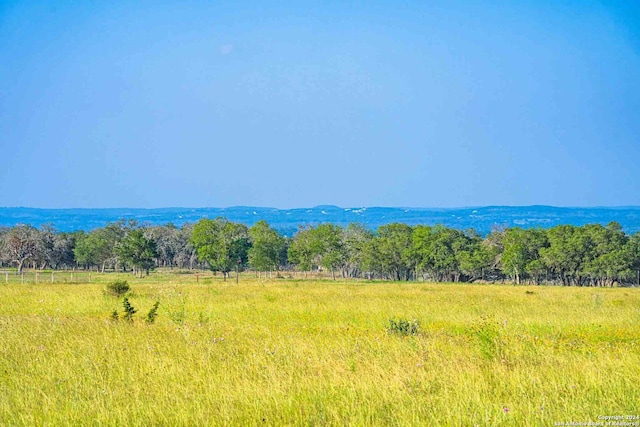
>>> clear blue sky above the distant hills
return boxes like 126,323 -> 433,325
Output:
0,0 -> 640,208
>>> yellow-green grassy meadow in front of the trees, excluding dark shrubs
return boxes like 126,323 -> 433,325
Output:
0,273 -> 640,426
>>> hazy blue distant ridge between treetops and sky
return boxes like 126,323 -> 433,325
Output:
0,205 -> 640,235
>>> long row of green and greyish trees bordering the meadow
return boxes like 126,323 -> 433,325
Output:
0,217 -> 640,286
